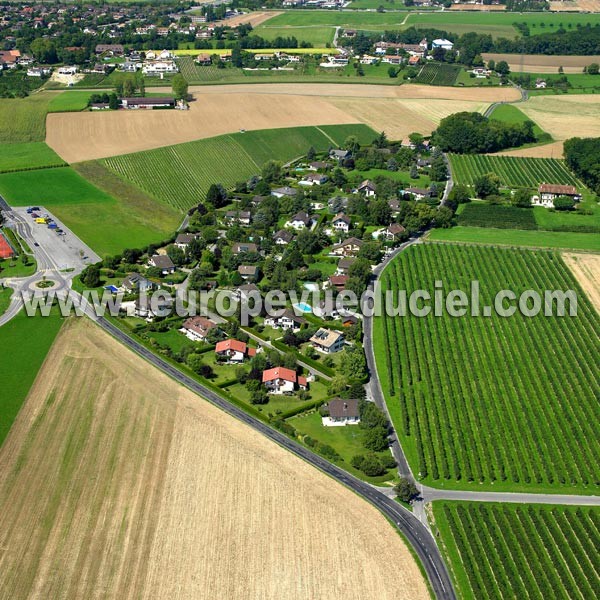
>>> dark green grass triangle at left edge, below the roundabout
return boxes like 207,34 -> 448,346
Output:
0,311 -> 62,445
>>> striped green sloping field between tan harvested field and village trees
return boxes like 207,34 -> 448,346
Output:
101,125 -> 376,211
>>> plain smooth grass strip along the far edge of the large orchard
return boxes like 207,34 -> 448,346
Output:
428,226 -> 600,252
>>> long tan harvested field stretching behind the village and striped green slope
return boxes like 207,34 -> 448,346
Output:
46,84 -> 520,163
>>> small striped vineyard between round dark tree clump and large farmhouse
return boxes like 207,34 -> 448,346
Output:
449,154 -> 581,189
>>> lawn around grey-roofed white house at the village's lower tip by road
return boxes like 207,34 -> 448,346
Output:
288,411 -> 396,483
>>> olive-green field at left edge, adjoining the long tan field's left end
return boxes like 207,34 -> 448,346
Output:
0,92 -> 53,143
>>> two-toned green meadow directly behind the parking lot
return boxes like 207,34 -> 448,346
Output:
0,167 -> 179,256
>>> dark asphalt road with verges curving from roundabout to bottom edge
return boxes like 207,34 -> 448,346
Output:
95,315 -> 456,600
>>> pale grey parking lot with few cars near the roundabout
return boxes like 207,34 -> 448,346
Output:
13,206 -> 100,272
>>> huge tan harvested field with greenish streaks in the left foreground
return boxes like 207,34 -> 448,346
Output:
0,319 -> 429,600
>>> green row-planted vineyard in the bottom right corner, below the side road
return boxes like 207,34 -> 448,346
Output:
433,502 -> 600,600
